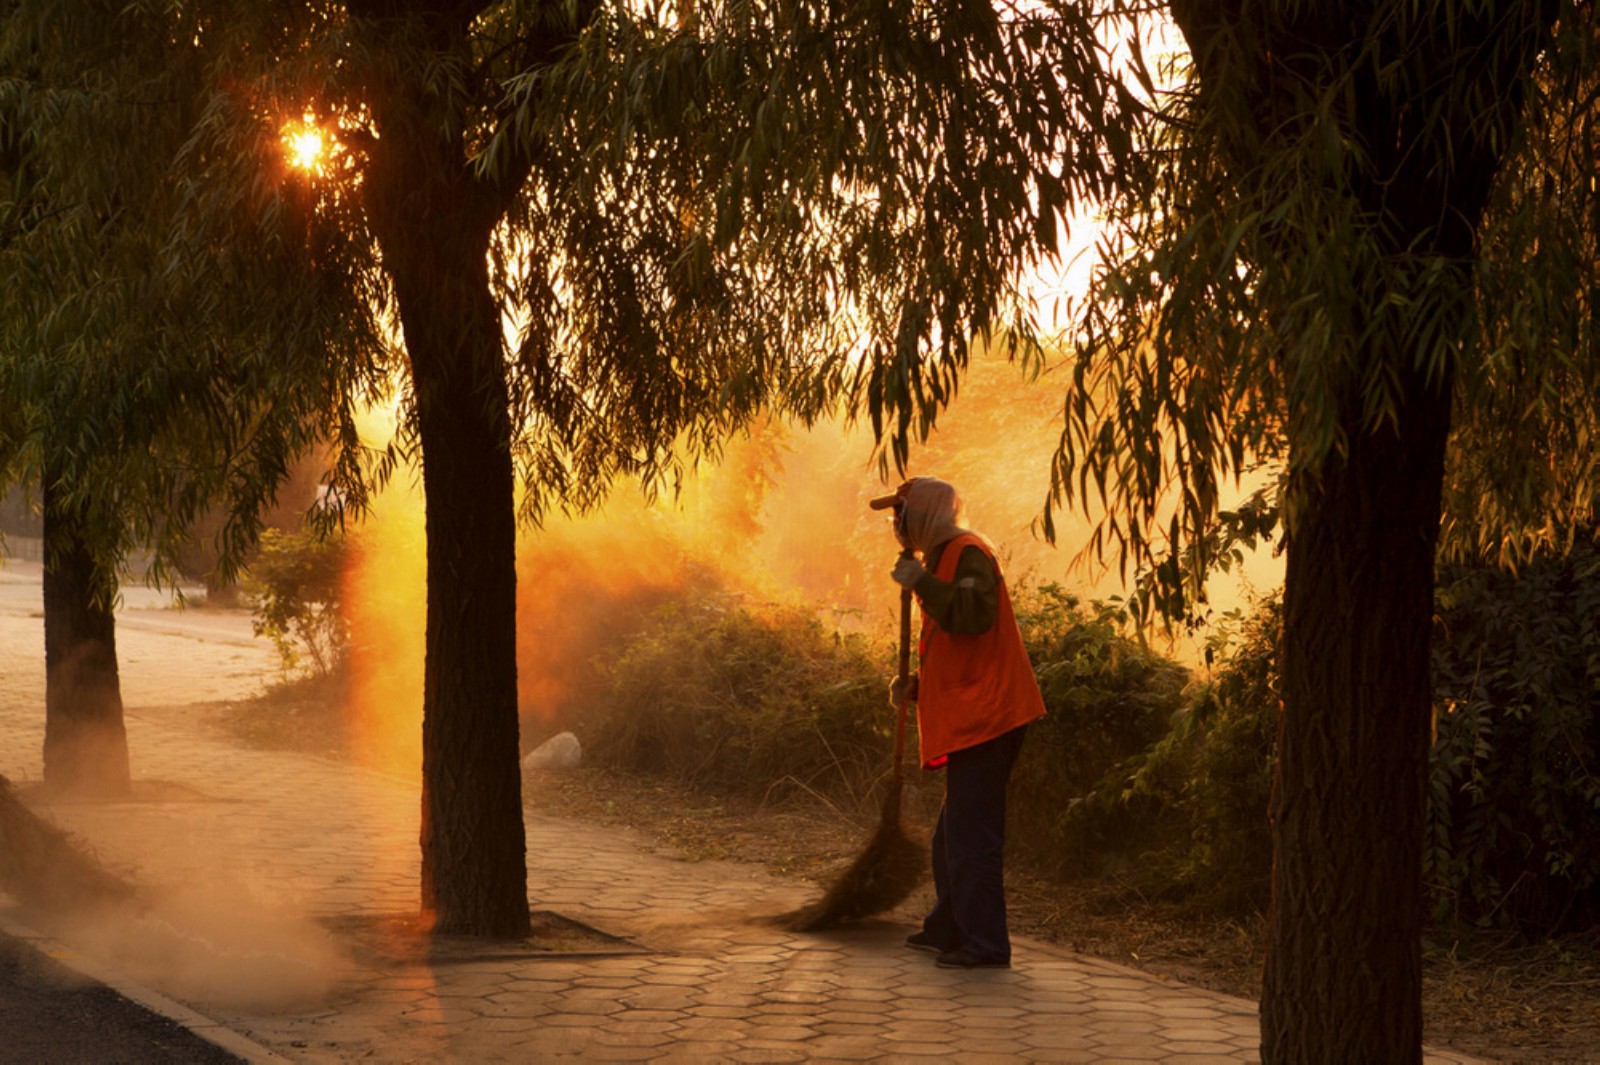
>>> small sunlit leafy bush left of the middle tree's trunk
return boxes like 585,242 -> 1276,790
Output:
246,529 -> 350,676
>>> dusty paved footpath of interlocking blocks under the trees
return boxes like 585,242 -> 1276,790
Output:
0,559 -> 1470,1065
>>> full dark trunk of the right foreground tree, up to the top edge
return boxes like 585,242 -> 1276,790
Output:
1171,0 -> 1555,1063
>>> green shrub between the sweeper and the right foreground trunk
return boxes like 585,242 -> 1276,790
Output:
1034,588 -> 1280,911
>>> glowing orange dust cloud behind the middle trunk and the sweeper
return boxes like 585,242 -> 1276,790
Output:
344,343 -> 1272,774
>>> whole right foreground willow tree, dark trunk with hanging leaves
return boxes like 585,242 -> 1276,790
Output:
1054,0 -> 1597,1062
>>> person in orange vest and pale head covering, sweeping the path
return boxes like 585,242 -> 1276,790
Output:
870,477 -> 1045,969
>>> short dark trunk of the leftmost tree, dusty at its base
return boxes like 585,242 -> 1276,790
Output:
43,477 -> 130,798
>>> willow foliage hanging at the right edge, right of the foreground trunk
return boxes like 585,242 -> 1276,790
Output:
1445,18 -> 1600,564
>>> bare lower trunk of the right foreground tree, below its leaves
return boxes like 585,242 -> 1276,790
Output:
1261,374 -> 1450,1065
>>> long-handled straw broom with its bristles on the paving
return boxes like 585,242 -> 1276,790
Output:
782,552 -> 928,932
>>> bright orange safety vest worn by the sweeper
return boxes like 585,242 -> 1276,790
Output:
917,533 -> 1045,769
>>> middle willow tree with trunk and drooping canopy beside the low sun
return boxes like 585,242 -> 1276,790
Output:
192,0 -> 1118,935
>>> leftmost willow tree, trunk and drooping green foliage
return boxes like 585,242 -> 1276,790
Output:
0,0 -> 379,796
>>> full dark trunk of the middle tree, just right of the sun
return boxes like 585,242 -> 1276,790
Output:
365,28 -> 531,939
